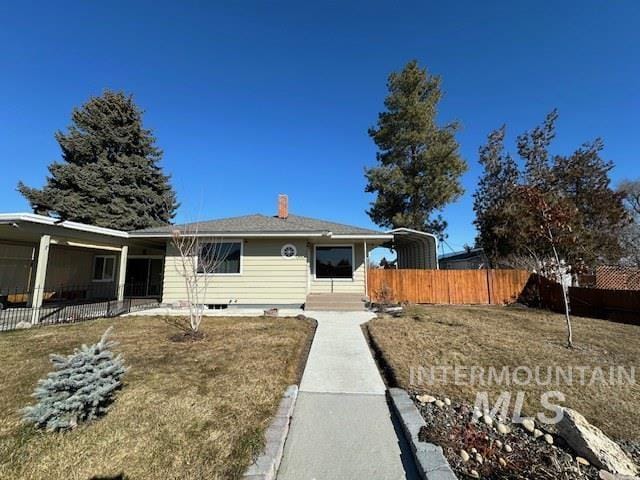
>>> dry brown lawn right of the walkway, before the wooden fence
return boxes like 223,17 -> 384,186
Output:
369,306 -> 640,440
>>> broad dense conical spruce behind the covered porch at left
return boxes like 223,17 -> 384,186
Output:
18,91 -> 178,230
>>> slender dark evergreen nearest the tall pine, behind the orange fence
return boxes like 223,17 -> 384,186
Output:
473,126 -> 521,266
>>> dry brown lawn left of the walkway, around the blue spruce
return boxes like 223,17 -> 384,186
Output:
0,317 -> 310,480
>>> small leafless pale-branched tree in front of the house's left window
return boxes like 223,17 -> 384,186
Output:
171,222 -> 233,334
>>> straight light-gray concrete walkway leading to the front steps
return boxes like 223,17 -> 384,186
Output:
278,312 -> 418,480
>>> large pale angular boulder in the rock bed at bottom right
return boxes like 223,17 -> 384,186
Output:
557,408 -> 638,476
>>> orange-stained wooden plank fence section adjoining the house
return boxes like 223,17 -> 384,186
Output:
367,269 -> 530,305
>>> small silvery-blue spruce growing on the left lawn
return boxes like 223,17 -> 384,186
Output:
23,327 -> 126,431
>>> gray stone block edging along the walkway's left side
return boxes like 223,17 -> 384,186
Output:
242,385 -> 298,480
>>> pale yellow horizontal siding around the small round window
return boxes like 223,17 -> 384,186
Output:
163,239 -> 308,305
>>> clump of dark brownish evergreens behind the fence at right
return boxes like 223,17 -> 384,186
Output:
474,110 -> 626,270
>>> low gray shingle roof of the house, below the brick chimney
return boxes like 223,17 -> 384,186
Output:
130,214 -> 383,235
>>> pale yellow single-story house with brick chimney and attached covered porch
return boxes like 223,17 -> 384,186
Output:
0,195 -> 437,316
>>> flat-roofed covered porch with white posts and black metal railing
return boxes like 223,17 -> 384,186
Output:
0,214 -> 163,323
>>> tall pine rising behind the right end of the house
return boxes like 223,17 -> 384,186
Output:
365,60 -> 467,237
